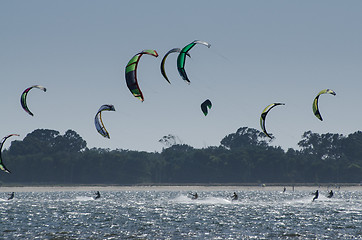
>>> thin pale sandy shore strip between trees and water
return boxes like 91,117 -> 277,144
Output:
0,185 -> 362,192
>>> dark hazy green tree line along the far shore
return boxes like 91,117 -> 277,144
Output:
0,127 -> 362,185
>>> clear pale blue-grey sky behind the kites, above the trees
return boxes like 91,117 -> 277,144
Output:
0,0 -> 362,152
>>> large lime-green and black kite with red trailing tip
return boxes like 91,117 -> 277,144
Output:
126,50 -> 158,102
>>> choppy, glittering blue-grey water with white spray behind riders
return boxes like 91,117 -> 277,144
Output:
0,187 -> 362,239
